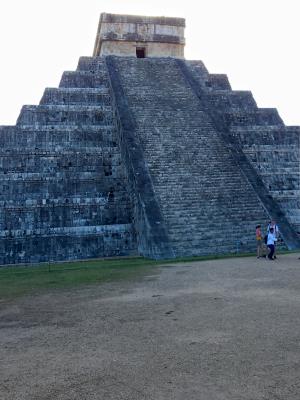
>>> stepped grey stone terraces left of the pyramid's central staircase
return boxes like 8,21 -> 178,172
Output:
0,58 -> 136,264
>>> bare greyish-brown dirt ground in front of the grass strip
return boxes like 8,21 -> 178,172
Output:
0,254 -> 300,400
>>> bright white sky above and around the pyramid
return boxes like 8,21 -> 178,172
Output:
0,0 -> 300,125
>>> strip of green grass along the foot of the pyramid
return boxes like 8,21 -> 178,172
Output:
0,252 -> 296,300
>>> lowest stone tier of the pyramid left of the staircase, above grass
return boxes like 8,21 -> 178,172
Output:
0,224 -> 137,265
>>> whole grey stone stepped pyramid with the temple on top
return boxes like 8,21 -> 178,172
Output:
0,14 -> 300,265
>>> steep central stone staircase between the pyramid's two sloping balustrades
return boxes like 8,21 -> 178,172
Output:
108,58 -> 269,256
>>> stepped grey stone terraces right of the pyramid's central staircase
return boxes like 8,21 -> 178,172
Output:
186,61 -> 300,233
